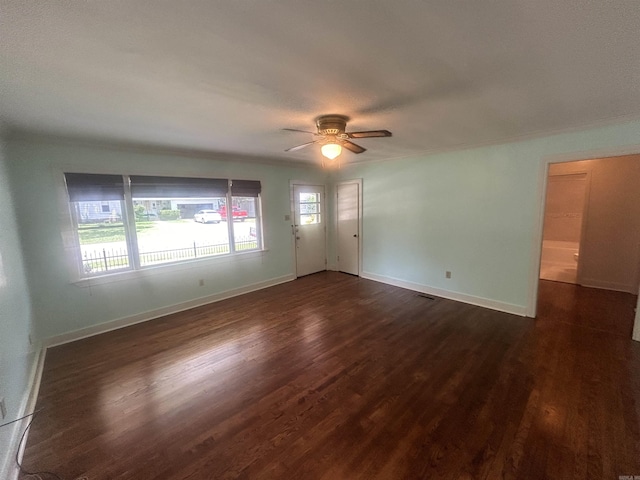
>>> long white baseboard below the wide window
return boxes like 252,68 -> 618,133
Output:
44,275 -> 296,347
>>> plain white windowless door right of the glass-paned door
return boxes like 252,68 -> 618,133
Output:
336,183 -> 360,275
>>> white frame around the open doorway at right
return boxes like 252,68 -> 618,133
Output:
525,145 -> 640,341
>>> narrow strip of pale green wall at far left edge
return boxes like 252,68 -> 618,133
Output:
0,137 -> 35,478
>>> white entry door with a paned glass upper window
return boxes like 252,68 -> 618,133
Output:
293,185 -> 327,277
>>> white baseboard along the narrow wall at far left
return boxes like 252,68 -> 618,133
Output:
0,347 -> 46,480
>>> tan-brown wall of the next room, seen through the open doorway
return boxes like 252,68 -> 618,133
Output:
549,155 -> 640,295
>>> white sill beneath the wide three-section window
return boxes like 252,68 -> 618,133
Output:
71,248 -> 269,287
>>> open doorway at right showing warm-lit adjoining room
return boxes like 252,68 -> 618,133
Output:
534,154 -> 640,340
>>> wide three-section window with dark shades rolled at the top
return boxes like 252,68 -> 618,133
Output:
65,173 -> 262,277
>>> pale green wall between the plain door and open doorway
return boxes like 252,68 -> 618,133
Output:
333,122 -> 640,313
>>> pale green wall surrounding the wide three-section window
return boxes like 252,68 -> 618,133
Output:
7,138 -> 326,340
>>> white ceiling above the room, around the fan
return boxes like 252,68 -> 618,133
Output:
0,0 -> 640,162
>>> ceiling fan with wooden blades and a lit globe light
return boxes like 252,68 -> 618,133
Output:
283,115 -> 391,165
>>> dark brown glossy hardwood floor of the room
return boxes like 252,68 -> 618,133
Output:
24,272 -> 640,480
